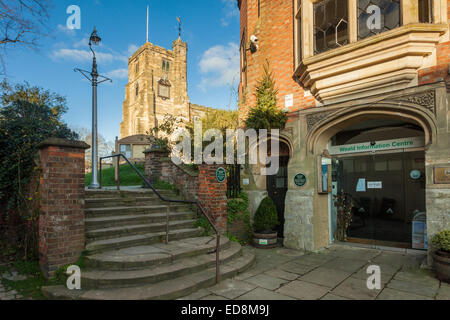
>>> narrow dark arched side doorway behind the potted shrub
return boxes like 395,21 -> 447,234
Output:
266,140 -> 290,238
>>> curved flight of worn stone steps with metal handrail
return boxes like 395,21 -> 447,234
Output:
42,189 -> 254,300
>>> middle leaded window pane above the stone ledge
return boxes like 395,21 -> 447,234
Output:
358,0 -> 400,39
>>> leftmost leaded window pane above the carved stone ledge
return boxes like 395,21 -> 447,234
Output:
314,0 -> 348,53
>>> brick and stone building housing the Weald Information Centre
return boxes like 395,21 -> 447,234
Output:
237,0 -> 450,258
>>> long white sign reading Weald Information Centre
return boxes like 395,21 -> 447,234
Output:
328,137 -> 425,155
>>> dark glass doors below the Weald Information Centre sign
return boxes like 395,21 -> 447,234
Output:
333,152 -> 425,247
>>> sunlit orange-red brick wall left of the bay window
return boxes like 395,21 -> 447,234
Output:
239,0 -> 315,123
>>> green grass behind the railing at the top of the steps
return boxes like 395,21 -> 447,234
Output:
85,164 -> 144,187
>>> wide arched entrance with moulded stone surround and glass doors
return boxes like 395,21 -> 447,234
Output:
307,101 -> 437,248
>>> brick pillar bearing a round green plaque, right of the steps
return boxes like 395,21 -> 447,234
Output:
198,164 -> 227,233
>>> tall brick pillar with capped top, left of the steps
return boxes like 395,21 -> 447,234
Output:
38,138 -> 89,278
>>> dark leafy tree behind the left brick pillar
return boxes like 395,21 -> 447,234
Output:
0,81 -> 77,260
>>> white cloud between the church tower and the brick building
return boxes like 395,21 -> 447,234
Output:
199,42 -> 239,91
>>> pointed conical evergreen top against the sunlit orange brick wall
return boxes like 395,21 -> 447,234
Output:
245,63 -> 287,130
